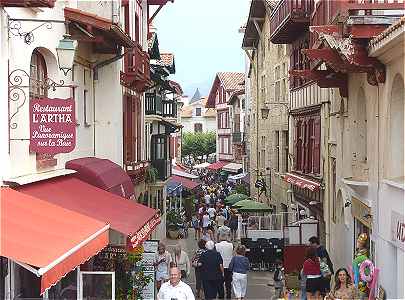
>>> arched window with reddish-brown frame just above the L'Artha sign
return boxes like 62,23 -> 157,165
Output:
30,50 -> 48,99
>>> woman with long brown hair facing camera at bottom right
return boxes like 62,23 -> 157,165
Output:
326,268 -> 359,300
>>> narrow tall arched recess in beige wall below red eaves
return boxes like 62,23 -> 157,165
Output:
356,88 -> 367,162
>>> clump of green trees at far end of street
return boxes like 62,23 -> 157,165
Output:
181,132 -> 216,160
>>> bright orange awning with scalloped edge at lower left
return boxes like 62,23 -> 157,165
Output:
0,188 -> 109,294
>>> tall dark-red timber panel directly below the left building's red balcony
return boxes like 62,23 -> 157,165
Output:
123,94 -> 142,166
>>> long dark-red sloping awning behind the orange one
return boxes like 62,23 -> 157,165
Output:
18,176 -> 160,248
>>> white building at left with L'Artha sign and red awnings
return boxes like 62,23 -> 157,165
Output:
0,0 -> 172,299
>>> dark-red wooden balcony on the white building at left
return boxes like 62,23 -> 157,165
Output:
121,45 -> 150,92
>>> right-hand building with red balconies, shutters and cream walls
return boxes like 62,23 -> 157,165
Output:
270,1 -> 405,298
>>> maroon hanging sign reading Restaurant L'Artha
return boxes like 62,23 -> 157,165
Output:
30,98 -> 76,154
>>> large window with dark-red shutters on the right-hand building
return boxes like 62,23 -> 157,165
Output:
294,112 -> 321,174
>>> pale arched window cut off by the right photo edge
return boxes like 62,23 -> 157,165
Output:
387,75 -> 405,178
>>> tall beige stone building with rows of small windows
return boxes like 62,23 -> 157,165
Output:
242,1 -> 292,216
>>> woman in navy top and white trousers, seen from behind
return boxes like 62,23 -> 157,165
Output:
229,245 -> 249,299
